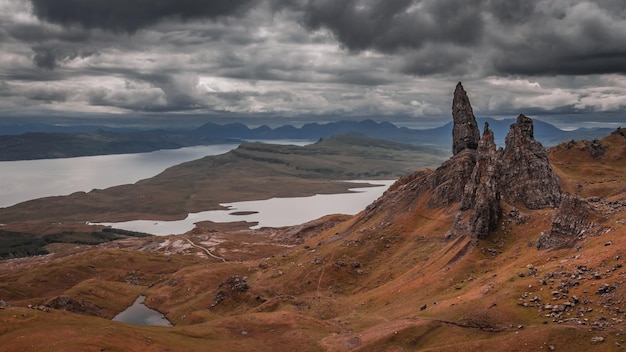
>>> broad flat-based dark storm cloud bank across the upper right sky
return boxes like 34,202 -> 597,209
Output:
294,0 -> 626,75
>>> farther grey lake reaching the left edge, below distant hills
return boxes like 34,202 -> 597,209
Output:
0,140 -> 312,207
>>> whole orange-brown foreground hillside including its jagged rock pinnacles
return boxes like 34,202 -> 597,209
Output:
0,84 -> 626,351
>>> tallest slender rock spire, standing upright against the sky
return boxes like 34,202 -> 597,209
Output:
452,82 -> 480,155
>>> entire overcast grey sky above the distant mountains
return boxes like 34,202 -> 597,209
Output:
0,0 -> 626,127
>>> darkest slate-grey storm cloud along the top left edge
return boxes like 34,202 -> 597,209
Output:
31,0 -> 255,33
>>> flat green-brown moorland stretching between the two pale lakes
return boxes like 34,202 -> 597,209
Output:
0,135 -> 448,256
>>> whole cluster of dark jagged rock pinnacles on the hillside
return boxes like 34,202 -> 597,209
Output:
442,88 -> 561,239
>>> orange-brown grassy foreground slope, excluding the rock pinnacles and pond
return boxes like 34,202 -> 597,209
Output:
0,131 -> 626,351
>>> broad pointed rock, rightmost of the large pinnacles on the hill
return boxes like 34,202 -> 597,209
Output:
500,115 -> 561,209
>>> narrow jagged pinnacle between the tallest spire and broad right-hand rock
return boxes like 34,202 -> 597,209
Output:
446,123 -> 502,238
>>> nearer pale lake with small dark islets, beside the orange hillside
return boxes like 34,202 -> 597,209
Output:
90,180 -> 395,236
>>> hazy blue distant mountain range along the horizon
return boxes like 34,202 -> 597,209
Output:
0,118 -> 611,161
